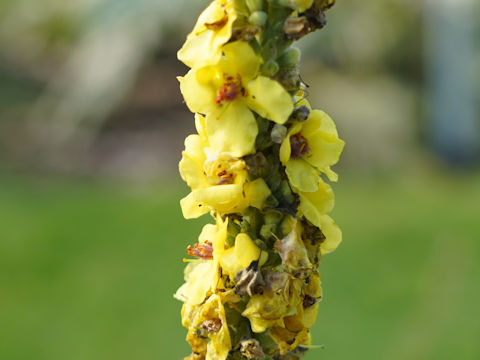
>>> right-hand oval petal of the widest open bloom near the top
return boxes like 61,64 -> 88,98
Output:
247,76 -> 293,124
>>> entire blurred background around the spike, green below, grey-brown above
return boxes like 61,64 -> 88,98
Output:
0,0 -> 480,360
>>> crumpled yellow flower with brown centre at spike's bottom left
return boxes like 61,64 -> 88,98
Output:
182,294 -> 232,360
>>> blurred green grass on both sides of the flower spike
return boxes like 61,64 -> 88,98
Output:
0,174 -> 480,360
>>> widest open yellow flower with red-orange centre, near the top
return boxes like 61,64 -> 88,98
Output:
179,41 -> 293,156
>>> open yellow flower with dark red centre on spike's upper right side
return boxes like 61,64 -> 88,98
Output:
280,110 -> 345,192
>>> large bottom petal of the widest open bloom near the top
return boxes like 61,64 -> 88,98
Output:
205,100 -> 258,157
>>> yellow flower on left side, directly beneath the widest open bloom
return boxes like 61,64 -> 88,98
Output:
179,117 -> 270,219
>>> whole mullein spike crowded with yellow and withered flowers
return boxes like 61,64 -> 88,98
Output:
175,0 -> 344,360
